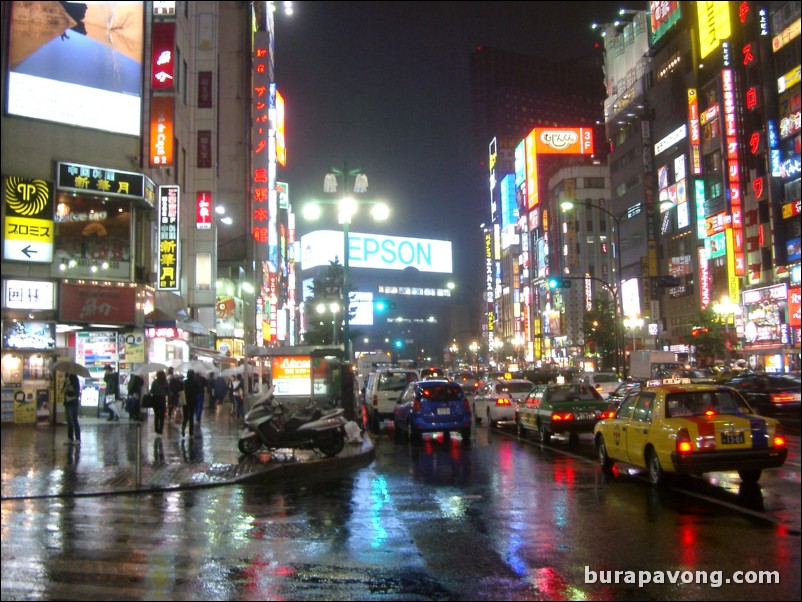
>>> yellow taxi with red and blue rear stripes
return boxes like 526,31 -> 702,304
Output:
593,379 -> 788,485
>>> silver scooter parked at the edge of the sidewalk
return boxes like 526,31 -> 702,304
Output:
237,394 -> 347,456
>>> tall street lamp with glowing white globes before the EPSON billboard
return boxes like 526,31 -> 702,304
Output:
303,162 -> 390,362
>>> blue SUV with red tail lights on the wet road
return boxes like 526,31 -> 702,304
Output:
393,380 -> 472,444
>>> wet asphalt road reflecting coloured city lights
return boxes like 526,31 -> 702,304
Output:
2,426 -> 800,600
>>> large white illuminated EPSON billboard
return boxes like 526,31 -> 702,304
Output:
301,230 -> 452,274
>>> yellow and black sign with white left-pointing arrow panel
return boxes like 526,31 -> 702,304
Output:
3,176 -> 54,263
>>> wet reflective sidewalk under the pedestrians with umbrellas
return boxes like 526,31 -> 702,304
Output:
0,404 -> 375,500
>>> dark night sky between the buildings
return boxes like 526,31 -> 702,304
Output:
275,2 -> 647,287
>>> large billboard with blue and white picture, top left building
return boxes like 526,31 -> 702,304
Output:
7,2 -> 144,136
